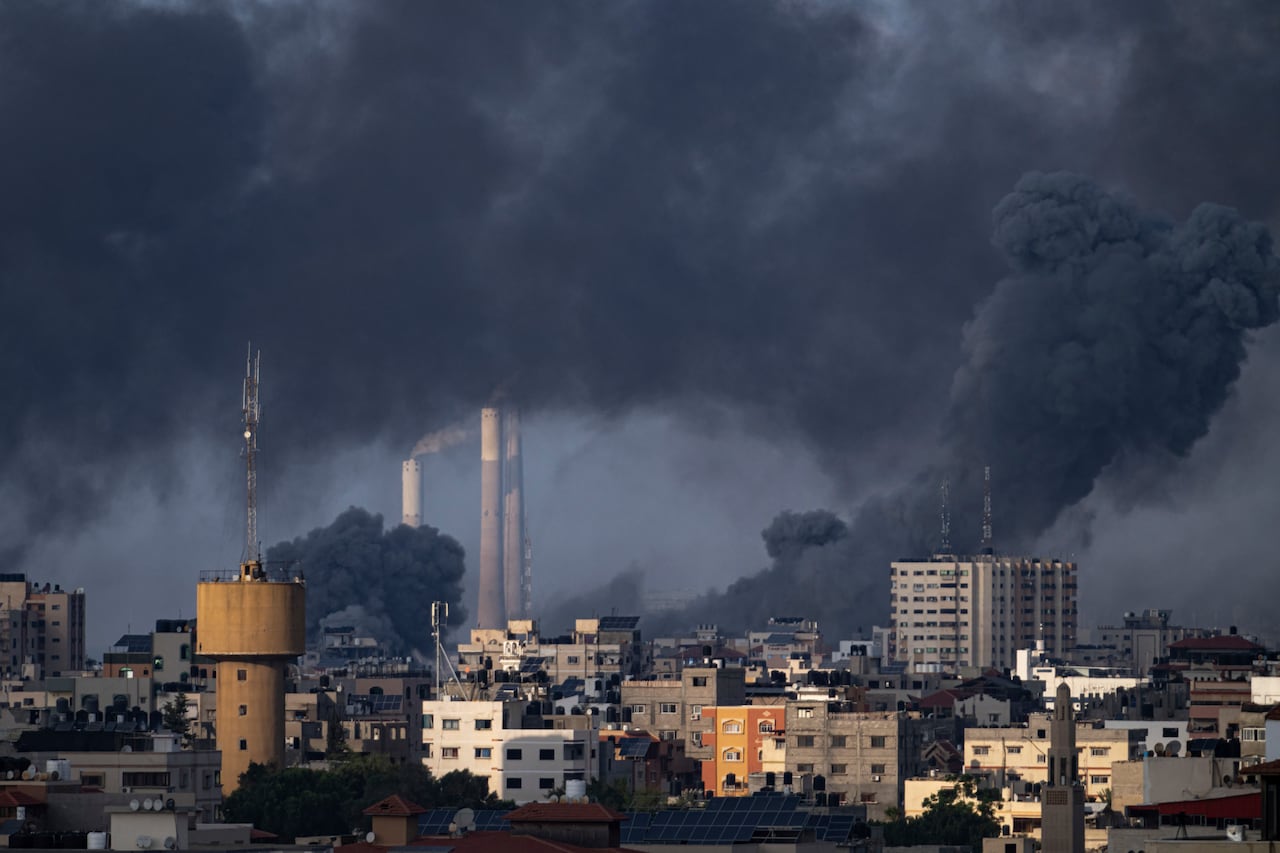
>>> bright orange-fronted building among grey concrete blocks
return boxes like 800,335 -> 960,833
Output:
701,704 -> 787,797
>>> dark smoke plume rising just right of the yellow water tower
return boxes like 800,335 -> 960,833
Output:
266,507 -> 466,654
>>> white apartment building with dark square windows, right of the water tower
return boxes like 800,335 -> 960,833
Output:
421,699 -> 599,804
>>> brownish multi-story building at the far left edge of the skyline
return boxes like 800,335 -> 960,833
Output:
0,573 -> 84,679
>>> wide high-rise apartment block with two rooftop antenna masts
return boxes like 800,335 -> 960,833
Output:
890,555 -> 1076,672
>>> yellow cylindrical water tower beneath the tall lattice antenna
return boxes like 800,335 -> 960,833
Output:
196,560 -> 306,792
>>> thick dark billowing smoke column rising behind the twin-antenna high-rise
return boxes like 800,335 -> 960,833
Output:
655,173 -> 1280,630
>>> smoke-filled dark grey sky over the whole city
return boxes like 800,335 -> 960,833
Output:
0,0 -> 1280,649
